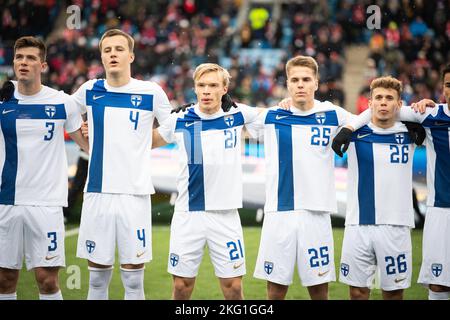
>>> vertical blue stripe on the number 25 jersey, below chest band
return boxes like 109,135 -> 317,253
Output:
275,124 -> 294,211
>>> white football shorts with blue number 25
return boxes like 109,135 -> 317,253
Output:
253,210 -> 336,287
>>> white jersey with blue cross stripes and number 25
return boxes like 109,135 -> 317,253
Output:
249,100 -> 354,212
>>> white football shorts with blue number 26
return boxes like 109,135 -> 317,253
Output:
339,225 -> 412,291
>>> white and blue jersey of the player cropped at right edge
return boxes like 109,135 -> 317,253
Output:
399,104 -> 450,208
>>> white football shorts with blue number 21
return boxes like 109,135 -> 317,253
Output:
167,210 -> 246,278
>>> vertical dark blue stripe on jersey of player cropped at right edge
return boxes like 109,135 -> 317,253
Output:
430,127 -> 450,208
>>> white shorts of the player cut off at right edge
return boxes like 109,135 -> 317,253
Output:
417,207 -> 450,287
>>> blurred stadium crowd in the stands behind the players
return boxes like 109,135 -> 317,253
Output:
0,0 -> 450,111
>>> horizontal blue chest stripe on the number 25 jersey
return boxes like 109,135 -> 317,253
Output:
265,109 -> 339,126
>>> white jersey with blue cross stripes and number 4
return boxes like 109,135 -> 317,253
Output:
73,78 -> 172,195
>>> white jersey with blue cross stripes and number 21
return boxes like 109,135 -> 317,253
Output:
158,104 -> 258,211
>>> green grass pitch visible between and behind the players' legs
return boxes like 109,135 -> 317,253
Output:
17,226 -> 427,300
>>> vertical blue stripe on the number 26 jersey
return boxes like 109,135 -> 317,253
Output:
355,141 -> 376,224
